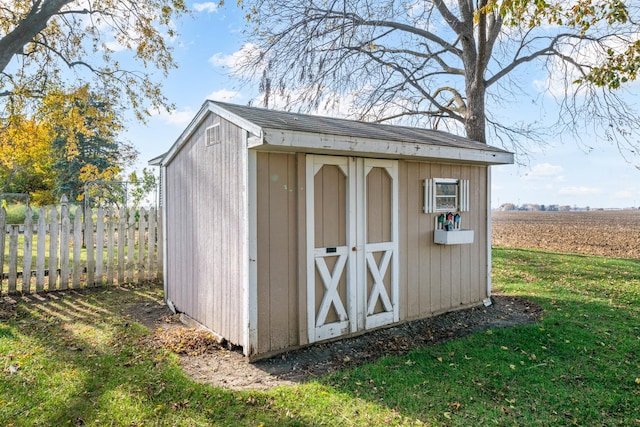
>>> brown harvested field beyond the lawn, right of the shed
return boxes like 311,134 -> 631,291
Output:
492,210 -> 640,259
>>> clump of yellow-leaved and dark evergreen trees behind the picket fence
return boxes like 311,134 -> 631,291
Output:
0,85 -> 137,204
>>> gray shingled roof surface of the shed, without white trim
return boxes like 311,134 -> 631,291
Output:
211,101 -> 508,153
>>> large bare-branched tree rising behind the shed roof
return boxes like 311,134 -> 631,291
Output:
235,0 -> 640,160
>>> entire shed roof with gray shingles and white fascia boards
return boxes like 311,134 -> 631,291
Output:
159,101 -> 513,165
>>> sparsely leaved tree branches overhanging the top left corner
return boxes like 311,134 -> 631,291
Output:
0,0 -> 186,120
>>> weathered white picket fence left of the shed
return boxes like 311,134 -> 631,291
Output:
0,198 -> 162,294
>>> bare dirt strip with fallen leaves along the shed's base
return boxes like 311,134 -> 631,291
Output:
126,295 -> 542,390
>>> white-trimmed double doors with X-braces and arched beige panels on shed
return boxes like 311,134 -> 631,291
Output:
306,155 -> 399,342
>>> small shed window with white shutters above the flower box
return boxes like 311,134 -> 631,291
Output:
424,178 -> 469,213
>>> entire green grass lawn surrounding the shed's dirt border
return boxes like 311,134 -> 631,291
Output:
0,249 -> 640,426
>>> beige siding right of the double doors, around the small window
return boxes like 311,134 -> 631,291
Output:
399,161 -> 487,319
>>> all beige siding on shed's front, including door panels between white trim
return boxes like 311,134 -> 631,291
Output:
256,152 -> 487,354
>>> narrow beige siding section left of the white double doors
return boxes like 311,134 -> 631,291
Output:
256,153 -> 304,353
